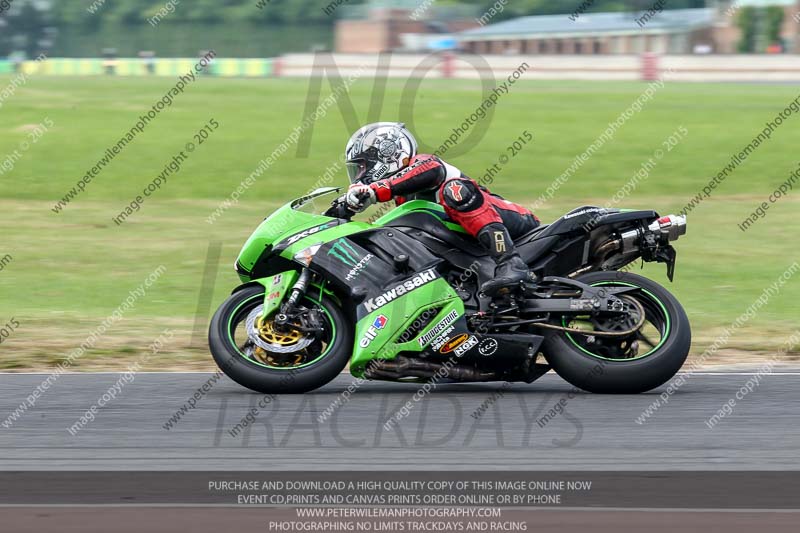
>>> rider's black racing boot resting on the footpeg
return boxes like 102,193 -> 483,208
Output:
477,222 -> 530,296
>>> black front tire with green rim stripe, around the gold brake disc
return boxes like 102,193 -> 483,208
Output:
208,286 -> 353,394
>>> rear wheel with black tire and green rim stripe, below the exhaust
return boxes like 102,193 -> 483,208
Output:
544,272 -> 692,394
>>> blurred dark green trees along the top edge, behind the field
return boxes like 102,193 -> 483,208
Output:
0,0 -> 706,56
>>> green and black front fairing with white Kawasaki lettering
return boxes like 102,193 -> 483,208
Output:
231,189 -> 478,376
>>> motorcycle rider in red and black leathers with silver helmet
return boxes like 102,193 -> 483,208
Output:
345,122 -> 539,295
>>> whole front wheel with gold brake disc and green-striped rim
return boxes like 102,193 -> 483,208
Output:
208,286 -> 353,394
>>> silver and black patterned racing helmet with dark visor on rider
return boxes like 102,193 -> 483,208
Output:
345,122 -> 417,185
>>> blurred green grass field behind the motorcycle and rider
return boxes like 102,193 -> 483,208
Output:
0,77 -> 800,369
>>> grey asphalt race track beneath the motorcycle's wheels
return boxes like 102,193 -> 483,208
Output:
0,368 -> 800,471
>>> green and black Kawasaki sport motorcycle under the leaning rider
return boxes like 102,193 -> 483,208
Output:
209,187 -> 691,394
